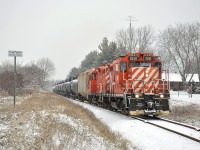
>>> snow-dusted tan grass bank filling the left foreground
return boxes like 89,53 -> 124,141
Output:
0,92 -> 135,149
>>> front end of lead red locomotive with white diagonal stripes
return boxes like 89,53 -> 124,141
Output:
121,53 -> 170,116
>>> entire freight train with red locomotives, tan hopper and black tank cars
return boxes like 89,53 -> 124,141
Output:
53,52 -> 170,116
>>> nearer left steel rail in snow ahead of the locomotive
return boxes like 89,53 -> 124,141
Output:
132,116 -> 200,143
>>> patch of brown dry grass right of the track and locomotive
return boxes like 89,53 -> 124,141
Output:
167,104 -> 200,127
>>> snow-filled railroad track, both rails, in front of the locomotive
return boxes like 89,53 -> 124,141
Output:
132,117 -> 200,143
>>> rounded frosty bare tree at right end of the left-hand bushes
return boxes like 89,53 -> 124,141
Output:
37,58 -> 55,87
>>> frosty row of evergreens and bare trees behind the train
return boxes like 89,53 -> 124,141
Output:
66,22 -> 200,84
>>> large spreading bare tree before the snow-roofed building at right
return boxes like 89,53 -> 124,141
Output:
158,24 -> 196,84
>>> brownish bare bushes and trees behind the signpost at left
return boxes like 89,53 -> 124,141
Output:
0,58 -> 55,95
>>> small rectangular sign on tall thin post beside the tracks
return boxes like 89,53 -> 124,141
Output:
8,51 -> 23,108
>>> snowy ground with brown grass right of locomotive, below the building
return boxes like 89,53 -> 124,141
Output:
166,91 -> 200,130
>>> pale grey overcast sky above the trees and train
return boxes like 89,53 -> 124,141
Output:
0,0 -> 200,79
